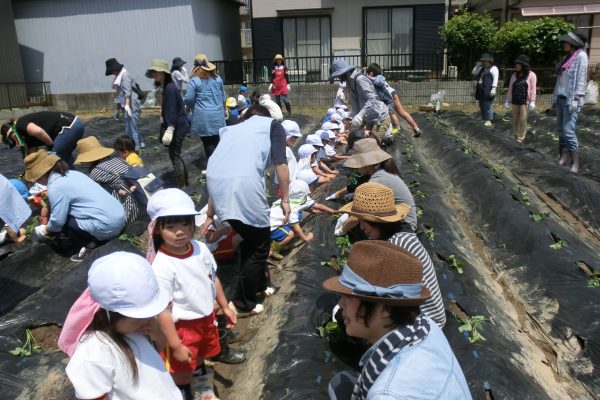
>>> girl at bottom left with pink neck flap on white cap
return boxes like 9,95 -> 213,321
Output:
58,251 -> 182,400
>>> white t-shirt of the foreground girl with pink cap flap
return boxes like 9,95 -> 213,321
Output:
66,332 -> 182,400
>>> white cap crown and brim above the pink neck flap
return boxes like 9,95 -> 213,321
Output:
88,251 -> 169,318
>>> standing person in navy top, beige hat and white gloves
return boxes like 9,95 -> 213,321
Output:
146,59 -> 190,187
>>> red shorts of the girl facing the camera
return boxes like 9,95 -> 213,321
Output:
160,312 -> 221,373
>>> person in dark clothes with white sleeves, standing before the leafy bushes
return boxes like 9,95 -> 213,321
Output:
472,54 -> 500,126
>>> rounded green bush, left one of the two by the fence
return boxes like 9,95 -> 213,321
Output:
440,8 -> 498,76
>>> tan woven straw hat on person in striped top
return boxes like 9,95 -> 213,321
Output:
337,182 -> 411,223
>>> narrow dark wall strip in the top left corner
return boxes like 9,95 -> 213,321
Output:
0,0 -> 23,82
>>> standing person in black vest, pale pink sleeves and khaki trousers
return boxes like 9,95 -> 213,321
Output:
504,55 -> 537,143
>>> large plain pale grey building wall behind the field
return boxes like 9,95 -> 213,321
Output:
14,0 -> 241,94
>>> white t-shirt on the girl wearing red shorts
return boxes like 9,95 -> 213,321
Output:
152,240 -> 217,322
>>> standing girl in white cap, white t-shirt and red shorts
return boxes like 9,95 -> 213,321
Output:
147,189 -> 237,400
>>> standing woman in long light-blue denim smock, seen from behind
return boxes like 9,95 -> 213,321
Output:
184,53 -> 227,160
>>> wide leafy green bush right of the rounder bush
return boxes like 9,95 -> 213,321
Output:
495,17 -> 574,67
